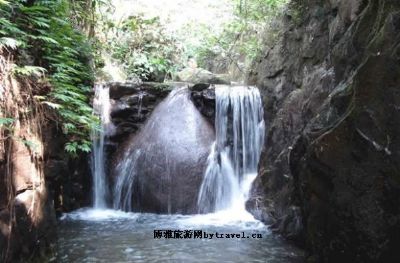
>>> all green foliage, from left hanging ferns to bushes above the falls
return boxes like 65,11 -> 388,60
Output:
0,0 -> 286,153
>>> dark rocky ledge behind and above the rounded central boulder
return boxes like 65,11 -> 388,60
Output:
106,82 -> 215,144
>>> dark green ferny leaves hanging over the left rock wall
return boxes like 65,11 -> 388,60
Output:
0,0 -> 97,153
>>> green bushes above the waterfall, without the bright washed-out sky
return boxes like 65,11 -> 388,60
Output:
97,0 -> 287,81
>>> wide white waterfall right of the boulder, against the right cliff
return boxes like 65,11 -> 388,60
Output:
197,85 -> 265,213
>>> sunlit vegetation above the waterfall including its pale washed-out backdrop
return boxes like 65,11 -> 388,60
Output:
101,0 -> 287,81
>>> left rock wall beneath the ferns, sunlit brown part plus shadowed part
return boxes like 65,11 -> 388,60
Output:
0,54 -> 90,263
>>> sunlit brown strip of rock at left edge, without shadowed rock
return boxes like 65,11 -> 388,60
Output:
0,75 -> 56,262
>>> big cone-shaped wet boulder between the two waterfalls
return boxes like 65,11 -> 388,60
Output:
112,88 -> 215,214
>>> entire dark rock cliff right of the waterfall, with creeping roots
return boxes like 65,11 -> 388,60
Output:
248,0 -> 400,262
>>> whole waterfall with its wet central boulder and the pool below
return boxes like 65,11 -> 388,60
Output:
56,86 -> 304,263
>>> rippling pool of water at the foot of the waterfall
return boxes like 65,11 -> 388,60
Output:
57,209 -> 303,263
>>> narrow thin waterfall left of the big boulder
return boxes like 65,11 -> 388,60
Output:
91,84 -> 114,208
